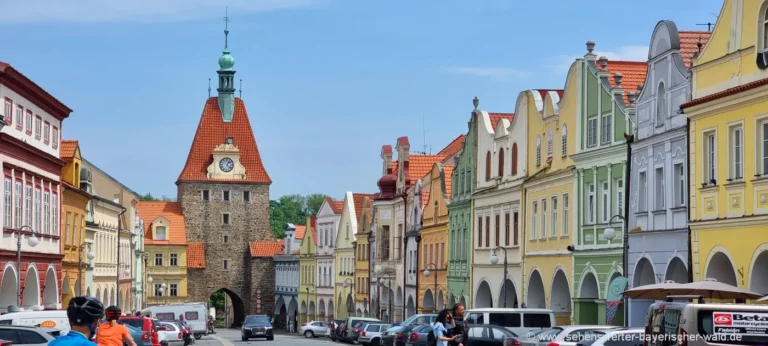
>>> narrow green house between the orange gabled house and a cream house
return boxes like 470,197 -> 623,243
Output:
448,98 -> 479,308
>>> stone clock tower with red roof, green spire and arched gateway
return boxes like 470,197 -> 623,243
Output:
176,14 -> 277,323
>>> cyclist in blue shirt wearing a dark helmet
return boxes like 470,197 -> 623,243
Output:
48,297 -> 104,346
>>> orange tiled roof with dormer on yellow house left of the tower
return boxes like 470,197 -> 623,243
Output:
136,201 -> 187,245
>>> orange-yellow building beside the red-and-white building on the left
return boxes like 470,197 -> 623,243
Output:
61,140 -> 94,306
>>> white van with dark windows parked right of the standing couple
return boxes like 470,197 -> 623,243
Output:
464,308 -> 555,336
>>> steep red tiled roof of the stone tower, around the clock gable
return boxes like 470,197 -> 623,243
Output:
176,97 -> 272,184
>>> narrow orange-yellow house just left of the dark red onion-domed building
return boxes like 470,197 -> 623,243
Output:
354,195 -> 373,317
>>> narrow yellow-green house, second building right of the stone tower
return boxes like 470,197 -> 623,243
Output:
296,216 -> 317,324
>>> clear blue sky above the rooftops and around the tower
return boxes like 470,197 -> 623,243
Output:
0,0 -> 722,198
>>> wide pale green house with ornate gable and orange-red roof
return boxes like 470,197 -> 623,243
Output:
572,41 -> 647,325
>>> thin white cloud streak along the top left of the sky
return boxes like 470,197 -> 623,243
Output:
1,0 -> 329,23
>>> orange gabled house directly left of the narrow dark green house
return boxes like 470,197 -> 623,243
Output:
420,163 -> 454,313
